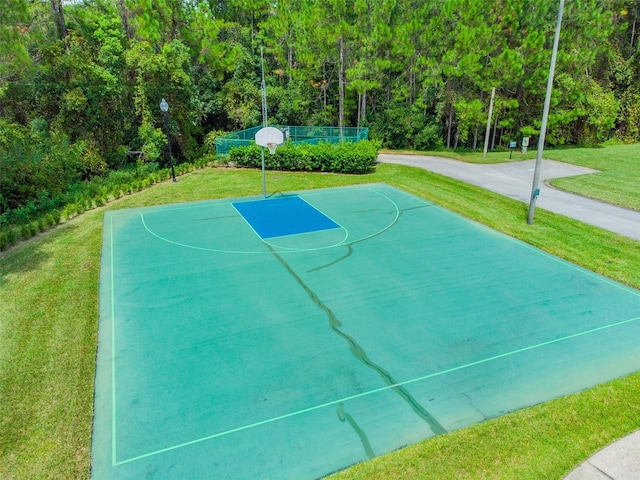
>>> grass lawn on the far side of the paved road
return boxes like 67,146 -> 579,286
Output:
384,144 -> 640,211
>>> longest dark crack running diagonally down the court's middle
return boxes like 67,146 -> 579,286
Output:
268,245 -> 447,435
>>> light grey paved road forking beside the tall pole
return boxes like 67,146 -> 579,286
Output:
378,154 -> 640,240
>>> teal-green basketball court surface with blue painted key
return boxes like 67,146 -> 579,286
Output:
92,184 -> 640,480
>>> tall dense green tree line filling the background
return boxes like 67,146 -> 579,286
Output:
0,0 -> 640,214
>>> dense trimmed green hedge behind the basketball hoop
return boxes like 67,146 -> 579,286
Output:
229,140 -> 380,174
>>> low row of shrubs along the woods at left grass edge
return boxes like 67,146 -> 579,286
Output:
0,160 -> 207,251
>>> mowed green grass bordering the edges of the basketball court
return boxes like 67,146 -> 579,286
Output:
0,157 -> 640,479
